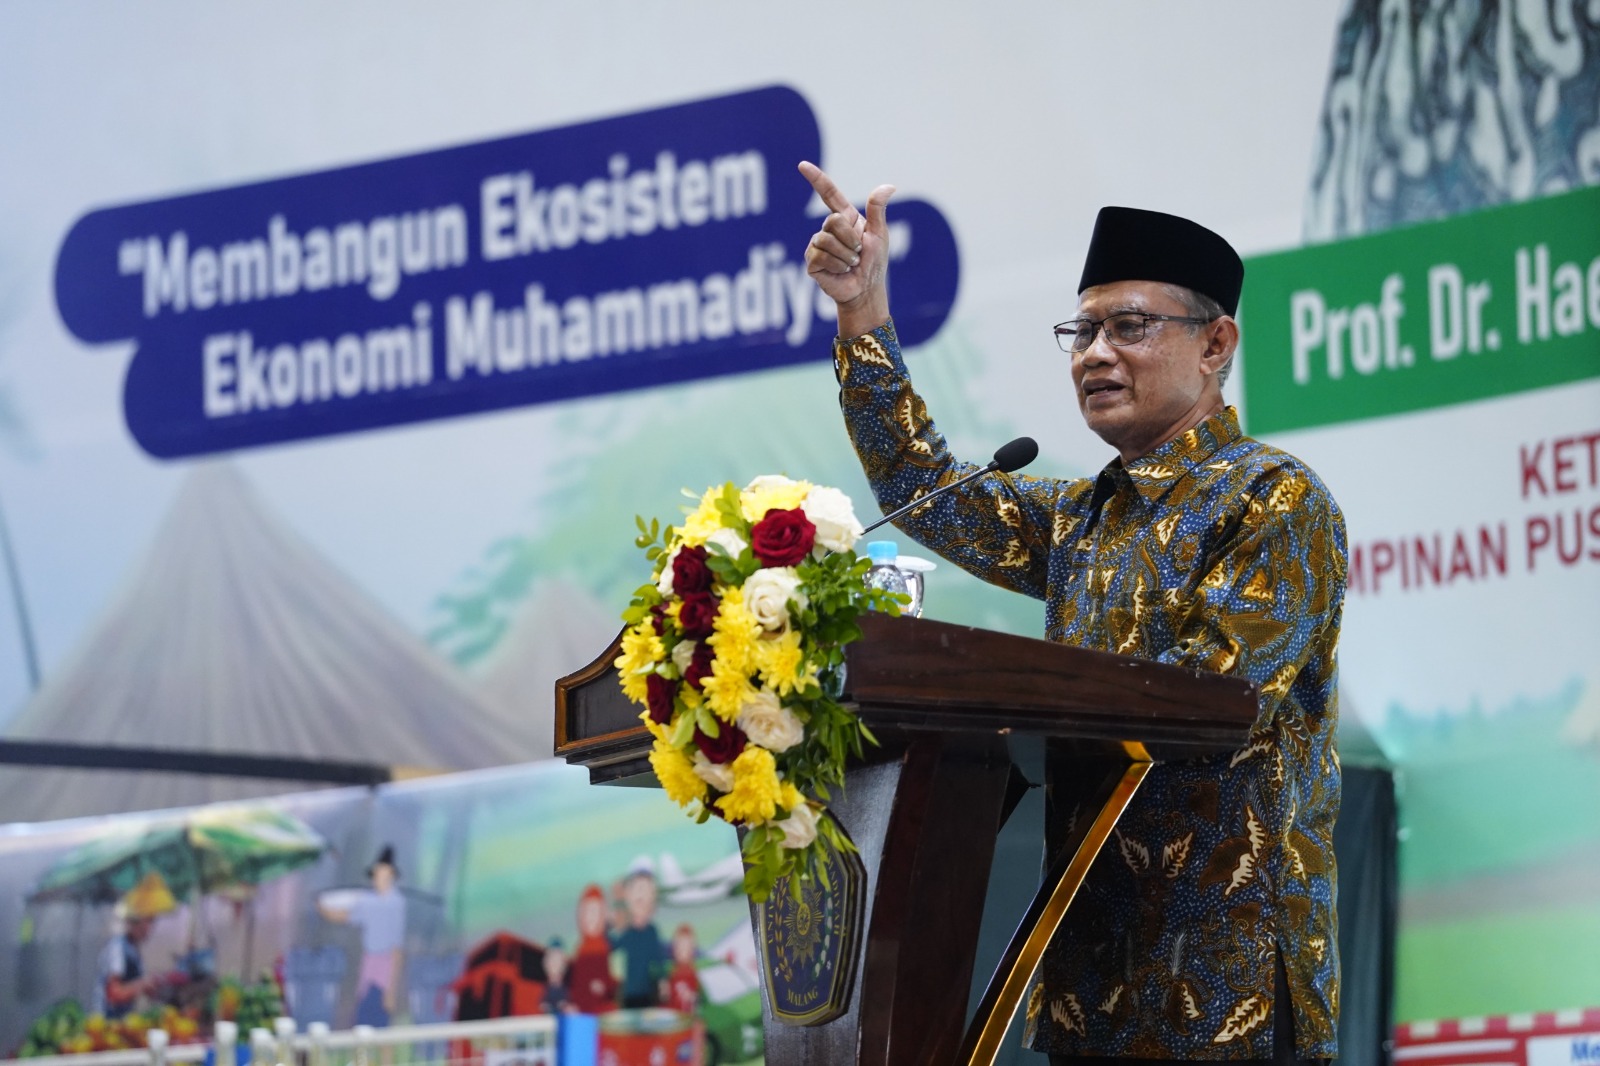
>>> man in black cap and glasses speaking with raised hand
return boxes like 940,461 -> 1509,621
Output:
800,163 -> 1346,1063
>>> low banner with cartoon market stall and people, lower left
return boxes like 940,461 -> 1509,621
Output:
0,762 -> 762,1063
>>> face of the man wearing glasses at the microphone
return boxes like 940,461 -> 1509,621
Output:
1072,282 -> 1226,461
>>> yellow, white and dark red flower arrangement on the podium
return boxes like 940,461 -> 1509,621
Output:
614,475 -> 904,901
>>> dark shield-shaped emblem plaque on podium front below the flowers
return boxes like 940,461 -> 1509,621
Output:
757,828 -> 867,1026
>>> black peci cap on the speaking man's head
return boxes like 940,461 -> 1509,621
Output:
1078,206 -> 1245,315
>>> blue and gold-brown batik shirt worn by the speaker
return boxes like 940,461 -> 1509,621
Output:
835,323 -> 1346,1060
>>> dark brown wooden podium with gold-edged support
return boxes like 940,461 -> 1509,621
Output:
555,615 -> 1256,1066
